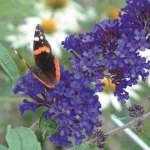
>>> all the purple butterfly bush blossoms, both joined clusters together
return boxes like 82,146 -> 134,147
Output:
14,0 -> 150,146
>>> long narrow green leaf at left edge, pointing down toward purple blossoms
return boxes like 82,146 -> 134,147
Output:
0,44 -> 20,82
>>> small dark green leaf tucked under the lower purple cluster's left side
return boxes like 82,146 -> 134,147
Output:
39,112 -> 58,139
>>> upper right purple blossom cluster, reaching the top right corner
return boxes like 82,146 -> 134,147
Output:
62,0 -> 150,103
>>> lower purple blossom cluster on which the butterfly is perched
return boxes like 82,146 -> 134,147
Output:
14,67 -> 101,146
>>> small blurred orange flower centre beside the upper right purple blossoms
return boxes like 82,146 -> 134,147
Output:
108,7 -> 120,19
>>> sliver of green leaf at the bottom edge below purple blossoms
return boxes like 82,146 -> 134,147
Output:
75,143 -> 99,150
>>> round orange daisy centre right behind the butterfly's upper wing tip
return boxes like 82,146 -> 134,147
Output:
41,19 -> 57,33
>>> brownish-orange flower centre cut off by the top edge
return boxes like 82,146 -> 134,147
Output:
45,0 -> 68,9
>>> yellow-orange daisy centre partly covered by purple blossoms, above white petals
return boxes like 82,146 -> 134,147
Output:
101,78 -> 116,93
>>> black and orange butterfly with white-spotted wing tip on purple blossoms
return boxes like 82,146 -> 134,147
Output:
12,25 -> 60,89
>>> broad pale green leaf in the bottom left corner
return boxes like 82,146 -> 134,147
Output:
6,125 -> 41,150
